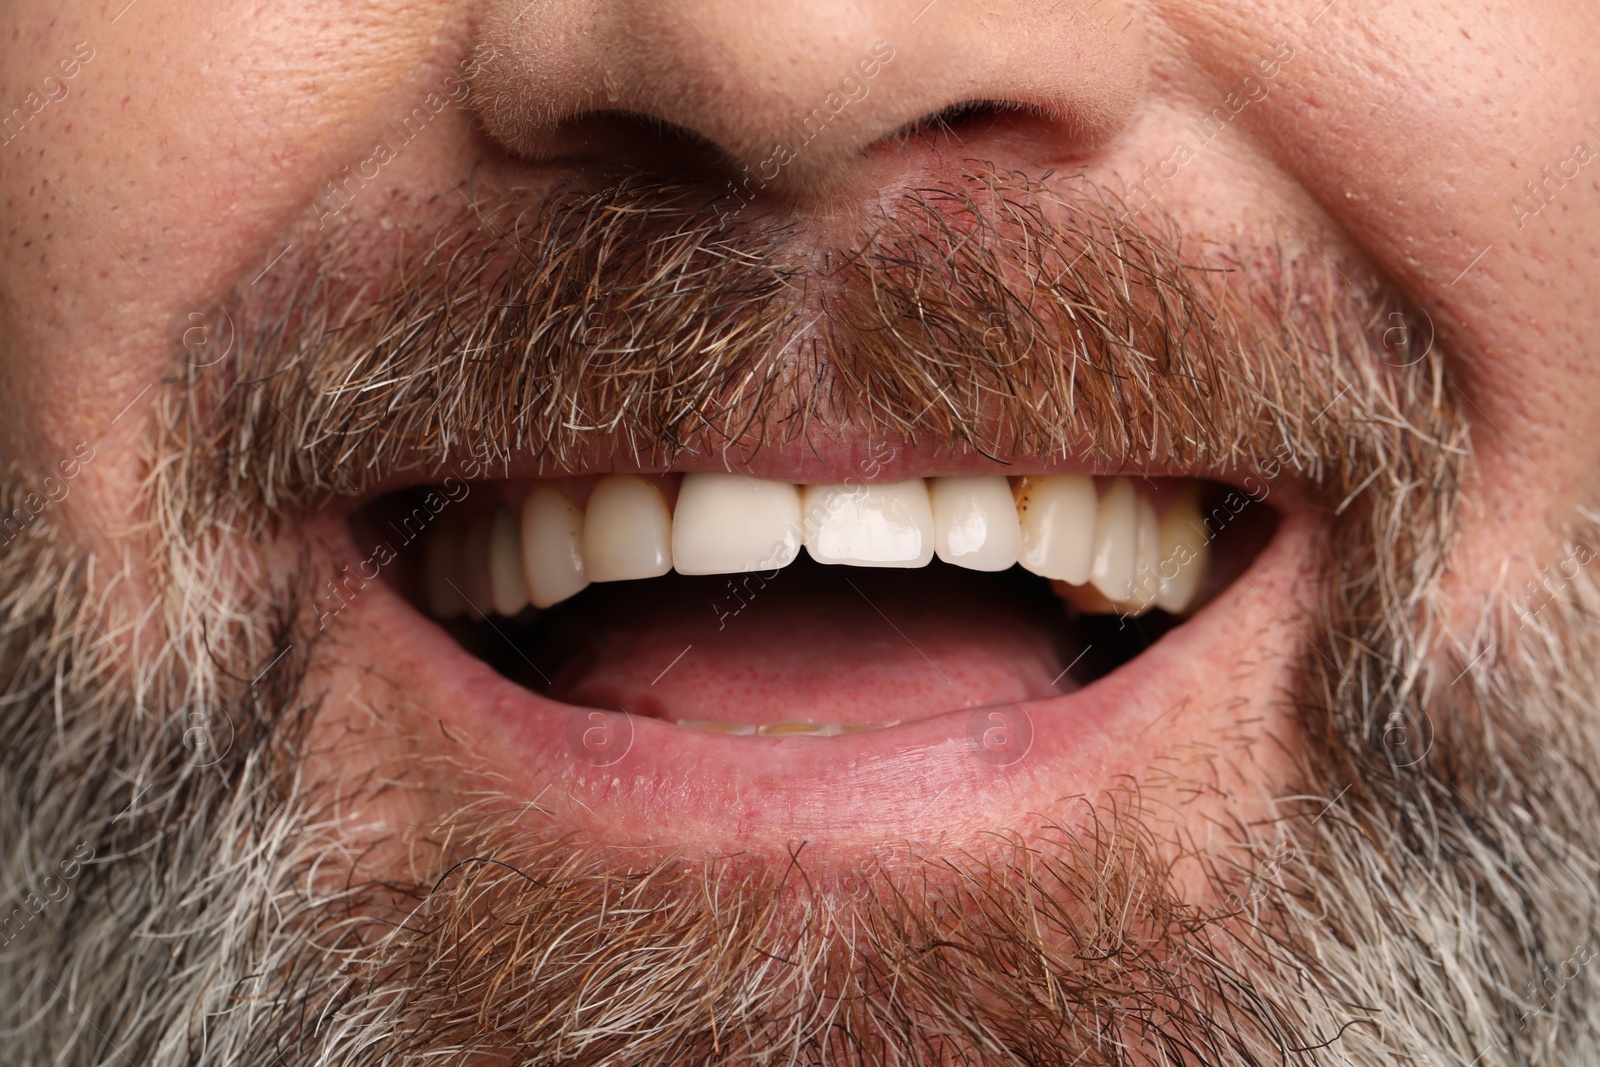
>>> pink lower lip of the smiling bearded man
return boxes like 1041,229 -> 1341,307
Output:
315,515 -> 1312,851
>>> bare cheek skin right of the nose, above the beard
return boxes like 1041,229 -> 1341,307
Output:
1162,0 -> 1600,607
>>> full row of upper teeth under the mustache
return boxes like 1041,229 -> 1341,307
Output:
426,472 -> 1206,617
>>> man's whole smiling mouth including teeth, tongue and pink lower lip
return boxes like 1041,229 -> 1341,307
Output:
341,462 -> 1286,848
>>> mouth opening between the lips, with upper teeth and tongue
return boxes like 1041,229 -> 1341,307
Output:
352,472 -> 1277,755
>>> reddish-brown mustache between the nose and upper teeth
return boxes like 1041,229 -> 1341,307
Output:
162,171 -> 1448,537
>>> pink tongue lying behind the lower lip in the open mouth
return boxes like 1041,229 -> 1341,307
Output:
531,557 -> 1077,726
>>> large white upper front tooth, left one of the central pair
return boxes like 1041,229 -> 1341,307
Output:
672,472 -> 802,574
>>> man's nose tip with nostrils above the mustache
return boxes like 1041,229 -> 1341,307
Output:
475,0 -> 1144,189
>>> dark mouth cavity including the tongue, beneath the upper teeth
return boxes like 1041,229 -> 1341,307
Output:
352,480 -> 1275,736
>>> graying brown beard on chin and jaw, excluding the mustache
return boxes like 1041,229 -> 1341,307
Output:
0,173 -> 1600,1065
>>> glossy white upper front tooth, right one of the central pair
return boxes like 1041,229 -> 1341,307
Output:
802,478 -> 933,566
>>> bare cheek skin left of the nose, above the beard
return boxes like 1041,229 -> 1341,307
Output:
0,0 -> 467,550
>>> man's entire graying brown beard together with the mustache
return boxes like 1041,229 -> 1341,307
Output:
0,174 -> 1600,1065
